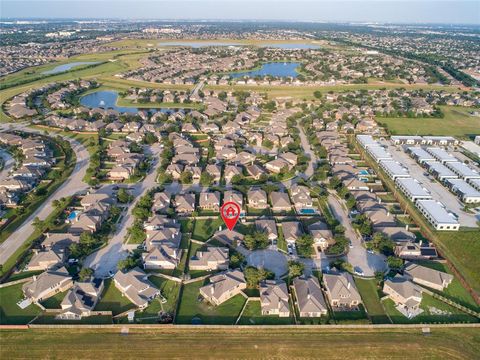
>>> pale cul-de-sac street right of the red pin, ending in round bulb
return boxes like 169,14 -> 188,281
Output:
328,193 -> 387,277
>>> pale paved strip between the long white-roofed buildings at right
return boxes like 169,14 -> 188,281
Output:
380,140 -> 480,227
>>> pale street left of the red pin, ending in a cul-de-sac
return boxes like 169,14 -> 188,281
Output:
83,144 -> 161,277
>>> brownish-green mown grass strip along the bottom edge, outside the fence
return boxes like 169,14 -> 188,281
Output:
0,327 -> 480,360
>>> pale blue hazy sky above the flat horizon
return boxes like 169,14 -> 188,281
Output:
0,0 -> 480,25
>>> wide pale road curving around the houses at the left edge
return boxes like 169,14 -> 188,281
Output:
0,123 -> 90,264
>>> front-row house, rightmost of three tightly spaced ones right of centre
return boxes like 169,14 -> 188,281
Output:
323,272 -> 362,310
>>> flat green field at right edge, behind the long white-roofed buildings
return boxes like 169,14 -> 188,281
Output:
377,106 -> 480,137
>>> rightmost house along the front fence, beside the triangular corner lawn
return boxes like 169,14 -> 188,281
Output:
383,274 -> 422,318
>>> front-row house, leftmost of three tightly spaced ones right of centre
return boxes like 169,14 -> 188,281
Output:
260,280 -> 290,317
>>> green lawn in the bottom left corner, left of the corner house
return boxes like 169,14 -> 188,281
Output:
0,284 -> 42,325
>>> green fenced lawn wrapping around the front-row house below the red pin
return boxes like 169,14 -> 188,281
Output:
176,280 -> 246,325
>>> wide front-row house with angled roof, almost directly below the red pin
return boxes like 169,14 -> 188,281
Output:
200,269 -> 247,305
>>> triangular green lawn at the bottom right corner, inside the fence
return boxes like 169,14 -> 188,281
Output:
383,293 -> 478,324
